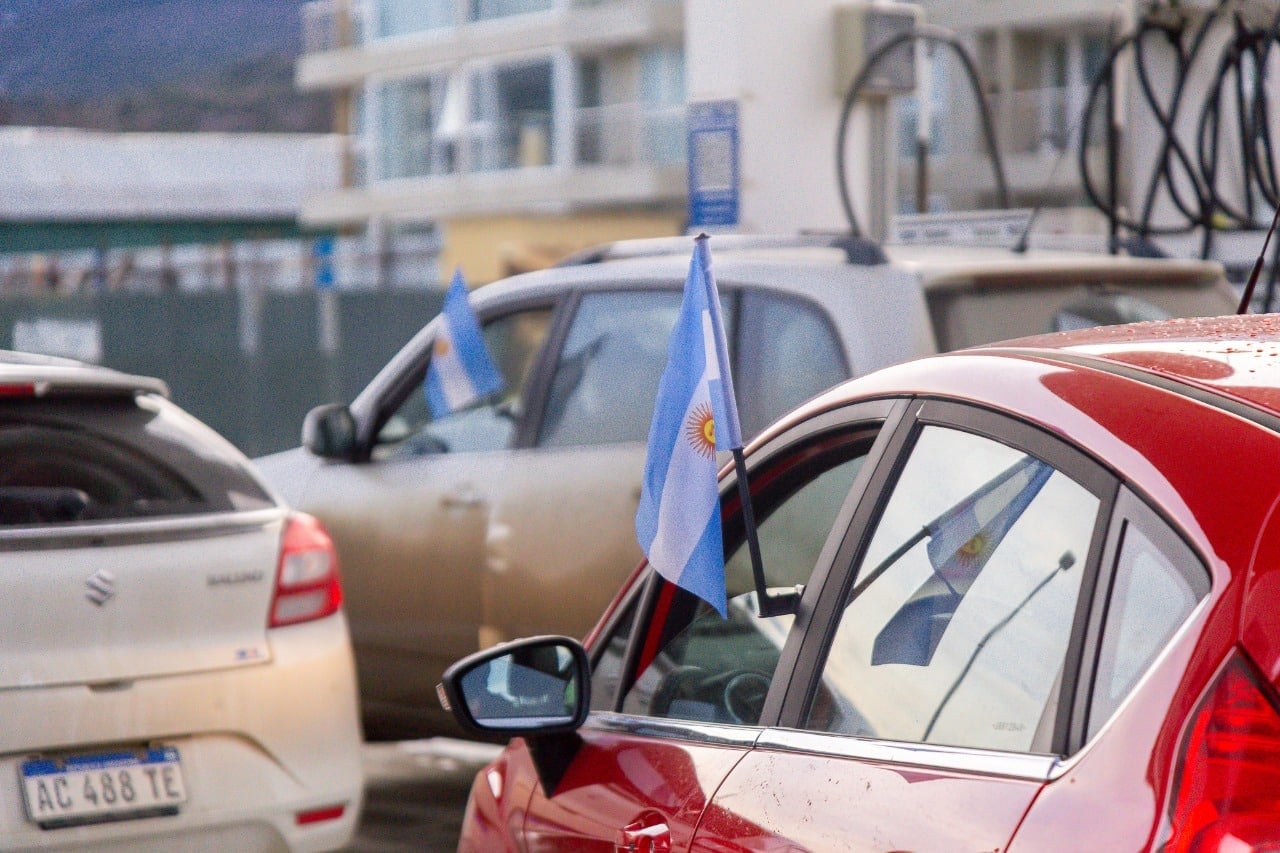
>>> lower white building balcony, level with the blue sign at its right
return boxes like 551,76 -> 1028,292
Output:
302,104 -> 686,225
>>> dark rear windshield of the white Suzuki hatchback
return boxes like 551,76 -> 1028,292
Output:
0,394 -> 273,525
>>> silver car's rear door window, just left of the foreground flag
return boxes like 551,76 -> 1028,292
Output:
538,291 -> 681,447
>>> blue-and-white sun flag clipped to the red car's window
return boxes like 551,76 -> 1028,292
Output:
636,234 -> 742,616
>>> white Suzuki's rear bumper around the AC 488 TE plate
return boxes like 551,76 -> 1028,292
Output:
0,613 -> 364,853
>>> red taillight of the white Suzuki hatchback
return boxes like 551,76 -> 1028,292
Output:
268,512 -> 342,628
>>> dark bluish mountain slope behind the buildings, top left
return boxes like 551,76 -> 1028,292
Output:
0,0 -> 332,132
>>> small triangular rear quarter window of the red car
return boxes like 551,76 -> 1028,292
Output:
1088,520 -> 1208,738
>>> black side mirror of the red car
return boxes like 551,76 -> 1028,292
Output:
435,637 -> 591,797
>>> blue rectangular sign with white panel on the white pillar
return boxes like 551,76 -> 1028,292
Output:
689,101 -> 740,228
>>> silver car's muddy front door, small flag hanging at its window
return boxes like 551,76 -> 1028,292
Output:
296,302 -> 554,725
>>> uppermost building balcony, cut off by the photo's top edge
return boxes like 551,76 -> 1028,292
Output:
294,0 -> 684,91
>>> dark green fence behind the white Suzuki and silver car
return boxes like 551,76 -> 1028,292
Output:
0,291 -> 444,456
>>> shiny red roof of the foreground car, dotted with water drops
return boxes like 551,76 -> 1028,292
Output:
970,314 -> 1280,415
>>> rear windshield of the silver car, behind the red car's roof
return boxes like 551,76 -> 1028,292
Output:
928,282 -> 1235,350
